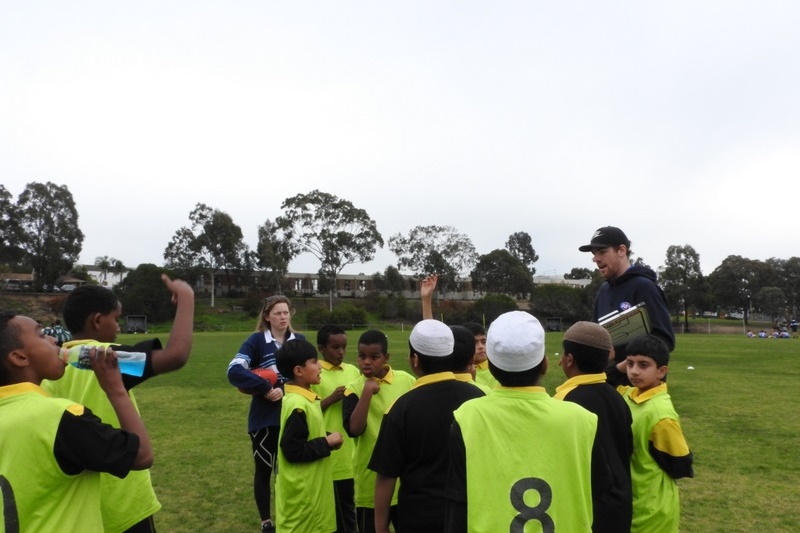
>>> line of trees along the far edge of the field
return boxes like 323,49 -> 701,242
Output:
0,182 -> 800,321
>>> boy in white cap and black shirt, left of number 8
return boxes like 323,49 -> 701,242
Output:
369,319 -> 485,533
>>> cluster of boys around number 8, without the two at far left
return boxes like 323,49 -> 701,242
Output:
266,280 -> 693,533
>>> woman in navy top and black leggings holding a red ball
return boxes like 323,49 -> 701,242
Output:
228,294 -> 305,533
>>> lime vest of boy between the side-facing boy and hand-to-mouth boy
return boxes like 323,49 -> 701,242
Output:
311,361 -> 360,481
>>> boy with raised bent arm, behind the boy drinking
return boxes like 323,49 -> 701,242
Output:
42,274 -> 194,533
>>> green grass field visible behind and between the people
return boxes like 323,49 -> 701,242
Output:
128,331 -> 800,533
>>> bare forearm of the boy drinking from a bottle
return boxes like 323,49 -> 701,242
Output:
91,349 -> 153,470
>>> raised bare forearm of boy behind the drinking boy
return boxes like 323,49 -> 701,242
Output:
153,274 -> 194,374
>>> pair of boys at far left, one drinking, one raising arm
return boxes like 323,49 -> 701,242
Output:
0,275 -> 194,533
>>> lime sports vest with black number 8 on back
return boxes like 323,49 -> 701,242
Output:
454,387 -> 597,533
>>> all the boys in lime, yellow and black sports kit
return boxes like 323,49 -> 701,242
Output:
0,277 -> 693,533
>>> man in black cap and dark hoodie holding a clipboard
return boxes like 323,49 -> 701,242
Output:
578,226 -> 675,368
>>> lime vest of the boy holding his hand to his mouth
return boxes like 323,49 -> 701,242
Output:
345,369 -> 416,508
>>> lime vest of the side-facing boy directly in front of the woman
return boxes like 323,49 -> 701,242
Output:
275,385 -> 339,533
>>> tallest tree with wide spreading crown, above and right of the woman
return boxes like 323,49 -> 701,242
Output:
275,189 -> 383,310
